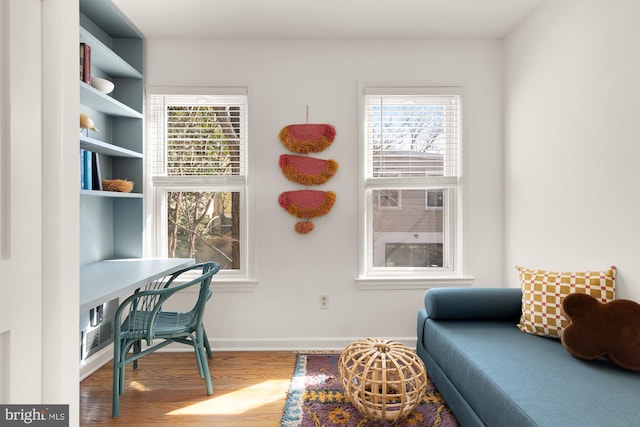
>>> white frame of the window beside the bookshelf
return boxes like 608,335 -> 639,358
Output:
145,87 -> 257,291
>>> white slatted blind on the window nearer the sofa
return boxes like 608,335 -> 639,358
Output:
365,90 -> 460,178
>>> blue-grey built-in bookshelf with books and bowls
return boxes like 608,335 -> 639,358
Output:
78,0 -> 144,370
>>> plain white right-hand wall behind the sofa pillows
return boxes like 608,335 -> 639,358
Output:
505,0 -> 640,300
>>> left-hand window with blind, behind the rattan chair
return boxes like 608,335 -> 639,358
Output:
147,90 -> 247,273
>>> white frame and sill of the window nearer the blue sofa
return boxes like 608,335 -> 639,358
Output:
356,82 -> 471,289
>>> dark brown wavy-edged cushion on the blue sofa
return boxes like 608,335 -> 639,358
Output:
562,294 -> 640,371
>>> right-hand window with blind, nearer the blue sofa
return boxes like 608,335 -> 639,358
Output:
361,88 -> 461,278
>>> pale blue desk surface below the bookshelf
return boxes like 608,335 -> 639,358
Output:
80,258 -> 195,313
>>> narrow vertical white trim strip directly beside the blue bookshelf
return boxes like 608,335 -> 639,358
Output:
41,0 -> 80,426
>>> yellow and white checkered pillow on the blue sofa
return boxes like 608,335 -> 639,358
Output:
516,266 -> 616,338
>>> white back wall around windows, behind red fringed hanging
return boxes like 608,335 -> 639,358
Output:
146,40 -> 504,348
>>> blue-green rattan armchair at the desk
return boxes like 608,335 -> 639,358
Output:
112,262 -> 220,417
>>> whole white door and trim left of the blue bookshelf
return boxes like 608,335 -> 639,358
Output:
0,0 -> 80,426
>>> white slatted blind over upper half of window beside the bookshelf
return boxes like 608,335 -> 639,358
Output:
148,95 -> 247,177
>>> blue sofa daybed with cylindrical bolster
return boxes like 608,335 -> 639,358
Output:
417,288 -> 640,427
